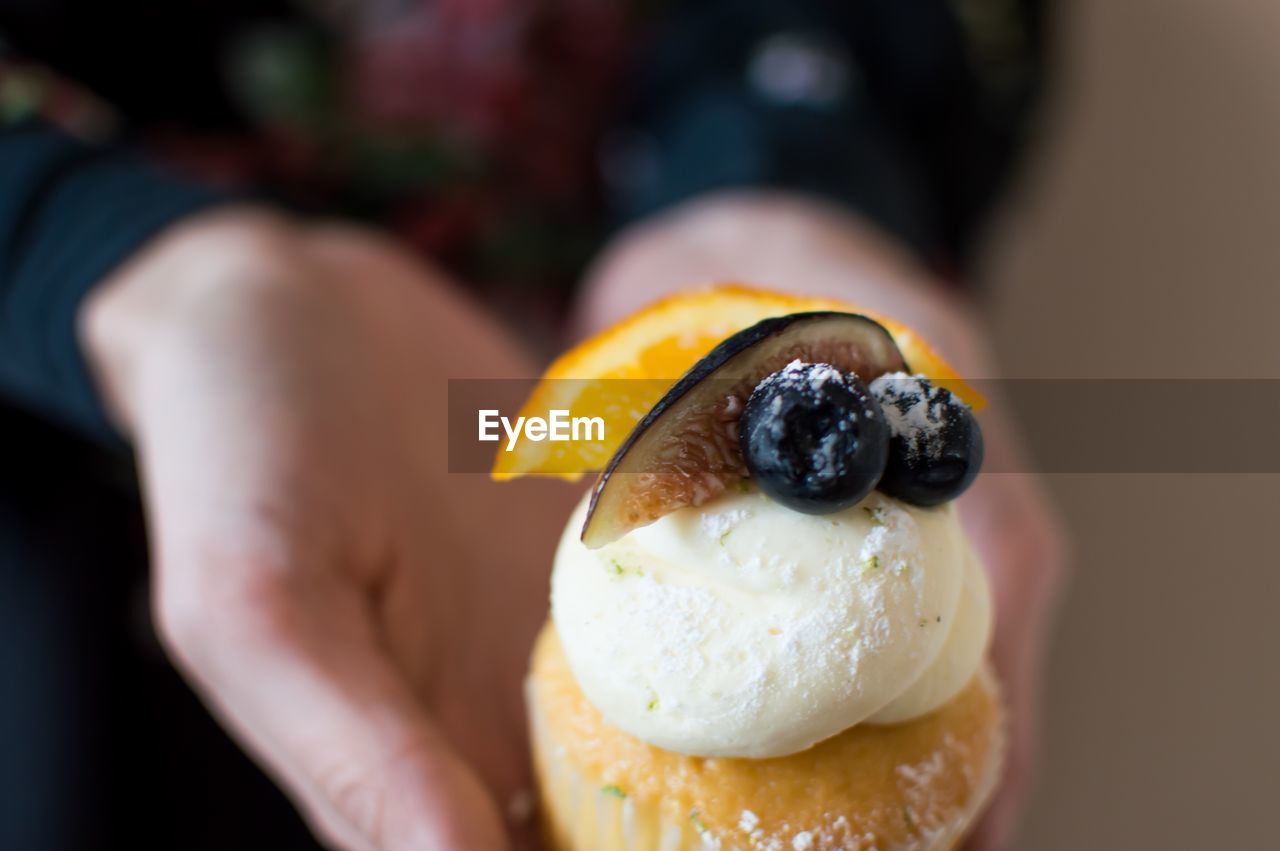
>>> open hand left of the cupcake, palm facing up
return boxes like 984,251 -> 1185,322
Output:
82,210 -> 573,851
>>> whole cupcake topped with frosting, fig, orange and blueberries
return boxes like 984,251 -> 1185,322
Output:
496,289 -> 1002,851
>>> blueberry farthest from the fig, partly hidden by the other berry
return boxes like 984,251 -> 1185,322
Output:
870,372 -> 983,505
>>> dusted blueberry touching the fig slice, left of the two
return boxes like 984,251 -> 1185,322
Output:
740,361 -> 890,514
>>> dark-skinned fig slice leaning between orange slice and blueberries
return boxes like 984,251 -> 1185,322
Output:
582,311 -> 910,549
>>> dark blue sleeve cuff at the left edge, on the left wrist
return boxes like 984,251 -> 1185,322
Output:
0,122 -> 229,443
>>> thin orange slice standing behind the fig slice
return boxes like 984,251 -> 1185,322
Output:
493,284 -> 983,481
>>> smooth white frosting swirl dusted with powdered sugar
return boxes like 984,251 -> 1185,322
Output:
552,483 -> 991,758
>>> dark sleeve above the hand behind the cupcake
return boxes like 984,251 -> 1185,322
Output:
602,0 -> 1043,271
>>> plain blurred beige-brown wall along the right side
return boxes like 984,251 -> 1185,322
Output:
983,0 -> 1280,851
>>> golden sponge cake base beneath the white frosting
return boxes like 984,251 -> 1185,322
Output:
526,624 -> 1004,851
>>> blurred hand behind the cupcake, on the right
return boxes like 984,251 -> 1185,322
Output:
577,192 -> 1065,851
